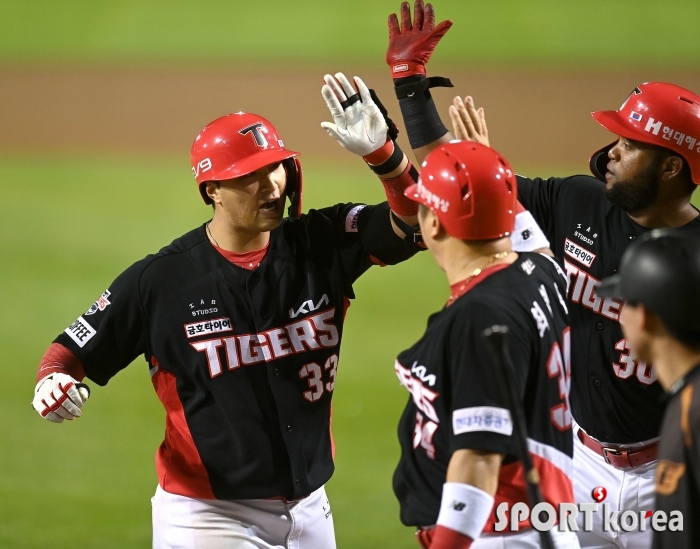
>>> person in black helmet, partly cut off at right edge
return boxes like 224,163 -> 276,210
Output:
598,230 -> 700,549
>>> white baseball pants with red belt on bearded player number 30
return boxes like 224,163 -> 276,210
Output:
574,426 -> 657,549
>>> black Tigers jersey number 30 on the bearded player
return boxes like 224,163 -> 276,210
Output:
518,175 -> 700,443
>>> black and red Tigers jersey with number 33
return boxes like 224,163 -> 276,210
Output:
55,203 -> 418,499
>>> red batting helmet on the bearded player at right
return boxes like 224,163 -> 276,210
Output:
590,82 -> 700,185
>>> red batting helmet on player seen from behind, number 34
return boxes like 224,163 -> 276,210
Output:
404,141 -> 518,240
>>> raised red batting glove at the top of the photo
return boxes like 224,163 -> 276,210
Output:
386,0 -> 452,78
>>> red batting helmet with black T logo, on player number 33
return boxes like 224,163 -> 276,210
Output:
190,112 -> 302,217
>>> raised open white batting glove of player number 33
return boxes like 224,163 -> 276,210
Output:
321,72 -> 388,156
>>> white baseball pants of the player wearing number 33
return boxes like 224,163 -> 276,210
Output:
151,486 -> 336,549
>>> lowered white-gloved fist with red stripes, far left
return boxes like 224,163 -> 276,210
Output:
32,373 -> 90,423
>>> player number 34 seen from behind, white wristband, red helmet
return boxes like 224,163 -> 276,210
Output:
394,141 -> 579,549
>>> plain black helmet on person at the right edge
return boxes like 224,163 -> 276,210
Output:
596,229 -> 700,346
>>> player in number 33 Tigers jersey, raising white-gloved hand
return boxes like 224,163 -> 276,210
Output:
33,74 -> 426,549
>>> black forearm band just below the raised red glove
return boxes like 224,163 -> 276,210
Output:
394,76 -> 449,149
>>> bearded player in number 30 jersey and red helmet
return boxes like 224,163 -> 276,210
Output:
450,82 -> 700,548
